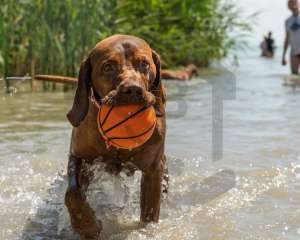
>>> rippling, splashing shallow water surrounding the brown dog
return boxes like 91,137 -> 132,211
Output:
0,49 -> 300,240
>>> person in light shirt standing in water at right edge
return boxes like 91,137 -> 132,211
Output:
282,0 -> 300,75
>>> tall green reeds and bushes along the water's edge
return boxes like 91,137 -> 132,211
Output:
0,0 -> 248,76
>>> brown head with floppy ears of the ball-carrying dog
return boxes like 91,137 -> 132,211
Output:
67,35 -> 165,127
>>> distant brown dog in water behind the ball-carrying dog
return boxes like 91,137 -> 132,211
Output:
161,64 -> 199,81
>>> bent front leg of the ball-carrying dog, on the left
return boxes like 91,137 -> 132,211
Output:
65,155 -> 102,239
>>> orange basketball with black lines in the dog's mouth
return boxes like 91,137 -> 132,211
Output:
98,105 -> 156,149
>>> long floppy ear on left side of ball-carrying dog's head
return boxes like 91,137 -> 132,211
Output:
67,57 -> 92,127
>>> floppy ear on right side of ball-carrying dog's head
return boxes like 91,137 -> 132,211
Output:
150,50 -> 166,117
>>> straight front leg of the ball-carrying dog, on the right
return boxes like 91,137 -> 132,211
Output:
140,161 -> 164,223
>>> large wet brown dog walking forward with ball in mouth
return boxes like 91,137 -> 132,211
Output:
65,35 -> 166,239
